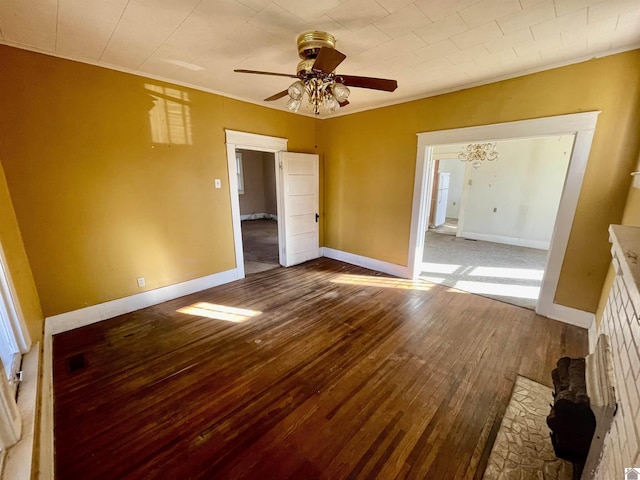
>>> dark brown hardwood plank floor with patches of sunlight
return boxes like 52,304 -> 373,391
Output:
53,259 -> 587,480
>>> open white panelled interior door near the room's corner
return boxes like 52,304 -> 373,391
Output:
278,152 -> 320,267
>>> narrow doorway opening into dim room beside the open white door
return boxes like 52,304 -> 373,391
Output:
236,149 -> 280,275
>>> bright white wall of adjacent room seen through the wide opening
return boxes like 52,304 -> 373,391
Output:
433,135 -> 574,249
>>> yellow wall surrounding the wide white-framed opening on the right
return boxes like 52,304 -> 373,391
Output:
322,50 -> 640,312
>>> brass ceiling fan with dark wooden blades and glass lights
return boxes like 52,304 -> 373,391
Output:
234,31 -> 398,115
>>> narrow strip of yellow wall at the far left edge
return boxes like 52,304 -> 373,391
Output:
0,161 -> 43,343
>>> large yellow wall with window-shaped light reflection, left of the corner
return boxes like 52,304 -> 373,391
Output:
0,46 -> 319,316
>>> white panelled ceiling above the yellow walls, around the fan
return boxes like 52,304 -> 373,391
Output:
0,0 -> 640,113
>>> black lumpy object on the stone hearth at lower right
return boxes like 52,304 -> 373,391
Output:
547,357 -> 596,480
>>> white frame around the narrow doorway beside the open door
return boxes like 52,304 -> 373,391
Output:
225,129 -> 288,279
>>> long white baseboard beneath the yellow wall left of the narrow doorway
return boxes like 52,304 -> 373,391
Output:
44,268 -> 240,335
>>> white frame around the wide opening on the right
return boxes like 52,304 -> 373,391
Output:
408,111 -> 601,317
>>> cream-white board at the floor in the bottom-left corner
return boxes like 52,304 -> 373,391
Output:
2,343 -> 40,480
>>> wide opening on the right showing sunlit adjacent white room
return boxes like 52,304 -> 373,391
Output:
420,134 -> 575,309
